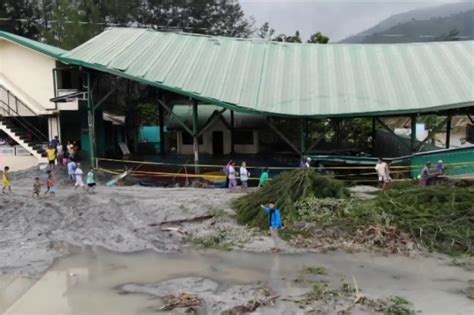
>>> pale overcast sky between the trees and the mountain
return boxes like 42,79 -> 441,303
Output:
240,0 -> 458,42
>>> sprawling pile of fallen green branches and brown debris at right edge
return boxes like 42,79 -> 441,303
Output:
290,185 -> 474,256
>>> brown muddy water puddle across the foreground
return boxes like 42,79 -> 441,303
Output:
0,249 -> 474,315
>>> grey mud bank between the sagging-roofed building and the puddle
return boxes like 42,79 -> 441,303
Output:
0,169 -> 290,274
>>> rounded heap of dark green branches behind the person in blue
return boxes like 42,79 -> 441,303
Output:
233,170 -> 349,229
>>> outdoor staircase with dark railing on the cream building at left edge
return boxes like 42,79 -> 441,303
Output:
0,85 -> 49,162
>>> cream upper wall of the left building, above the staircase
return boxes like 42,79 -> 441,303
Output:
0,40 -> 56,111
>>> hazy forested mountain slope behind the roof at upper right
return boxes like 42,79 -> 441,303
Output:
341,2 -> 474,43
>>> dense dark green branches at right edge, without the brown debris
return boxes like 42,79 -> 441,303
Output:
350,186 -> 474,255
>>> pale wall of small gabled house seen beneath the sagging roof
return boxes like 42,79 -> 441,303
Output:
176,121 -> 259,154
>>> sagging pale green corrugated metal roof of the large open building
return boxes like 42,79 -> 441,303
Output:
65,28 -> 474,116
